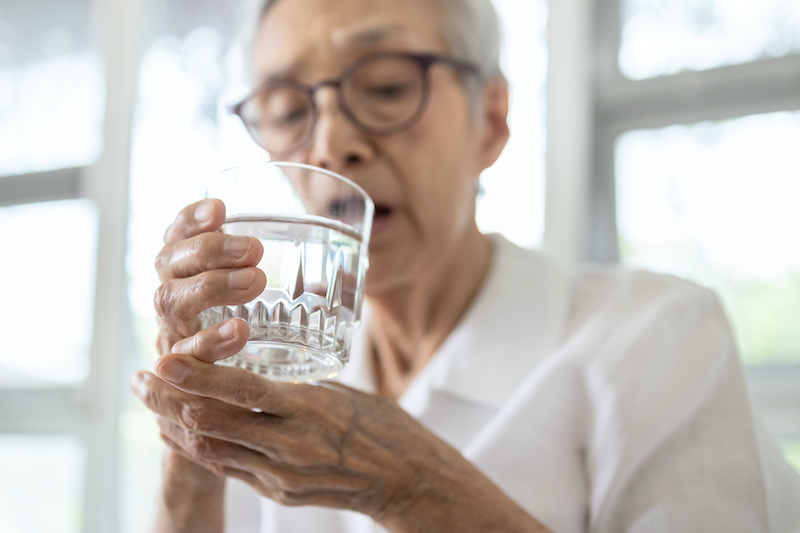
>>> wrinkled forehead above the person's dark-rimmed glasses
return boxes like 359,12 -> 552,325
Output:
252,0 -> 447,80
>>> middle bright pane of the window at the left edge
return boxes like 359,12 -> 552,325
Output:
0,200 -> 97,388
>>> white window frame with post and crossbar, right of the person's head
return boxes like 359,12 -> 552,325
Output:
545,0 -> 800,438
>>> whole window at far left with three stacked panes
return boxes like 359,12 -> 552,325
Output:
0,0 -> 135,533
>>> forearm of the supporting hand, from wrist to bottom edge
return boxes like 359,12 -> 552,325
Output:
381,458 -> 550,533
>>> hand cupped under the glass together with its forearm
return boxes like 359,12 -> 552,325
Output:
131,319 -> 548,533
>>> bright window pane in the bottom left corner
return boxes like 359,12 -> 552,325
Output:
0,435 -> 85,533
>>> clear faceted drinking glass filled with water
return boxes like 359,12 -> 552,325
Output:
200,162 -> 374,382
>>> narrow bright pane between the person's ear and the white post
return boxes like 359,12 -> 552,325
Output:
477,0 -> 547,247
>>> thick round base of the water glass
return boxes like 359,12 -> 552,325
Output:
217,341 -> 343,383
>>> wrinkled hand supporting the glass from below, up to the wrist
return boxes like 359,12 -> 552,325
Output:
132,344 -> 444,521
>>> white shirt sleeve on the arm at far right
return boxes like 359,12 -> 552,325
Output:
584,273 -> 800,533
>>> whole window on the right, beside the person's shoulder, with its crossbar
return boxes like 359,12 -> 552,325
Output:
585,0 -> 800,466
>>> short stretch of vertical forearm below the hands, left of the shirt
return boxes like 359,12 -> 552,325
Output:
153,450 -> 225,533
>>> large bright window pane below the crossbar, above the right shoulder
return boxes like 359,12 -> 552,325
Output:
616,112 -> 800,365
